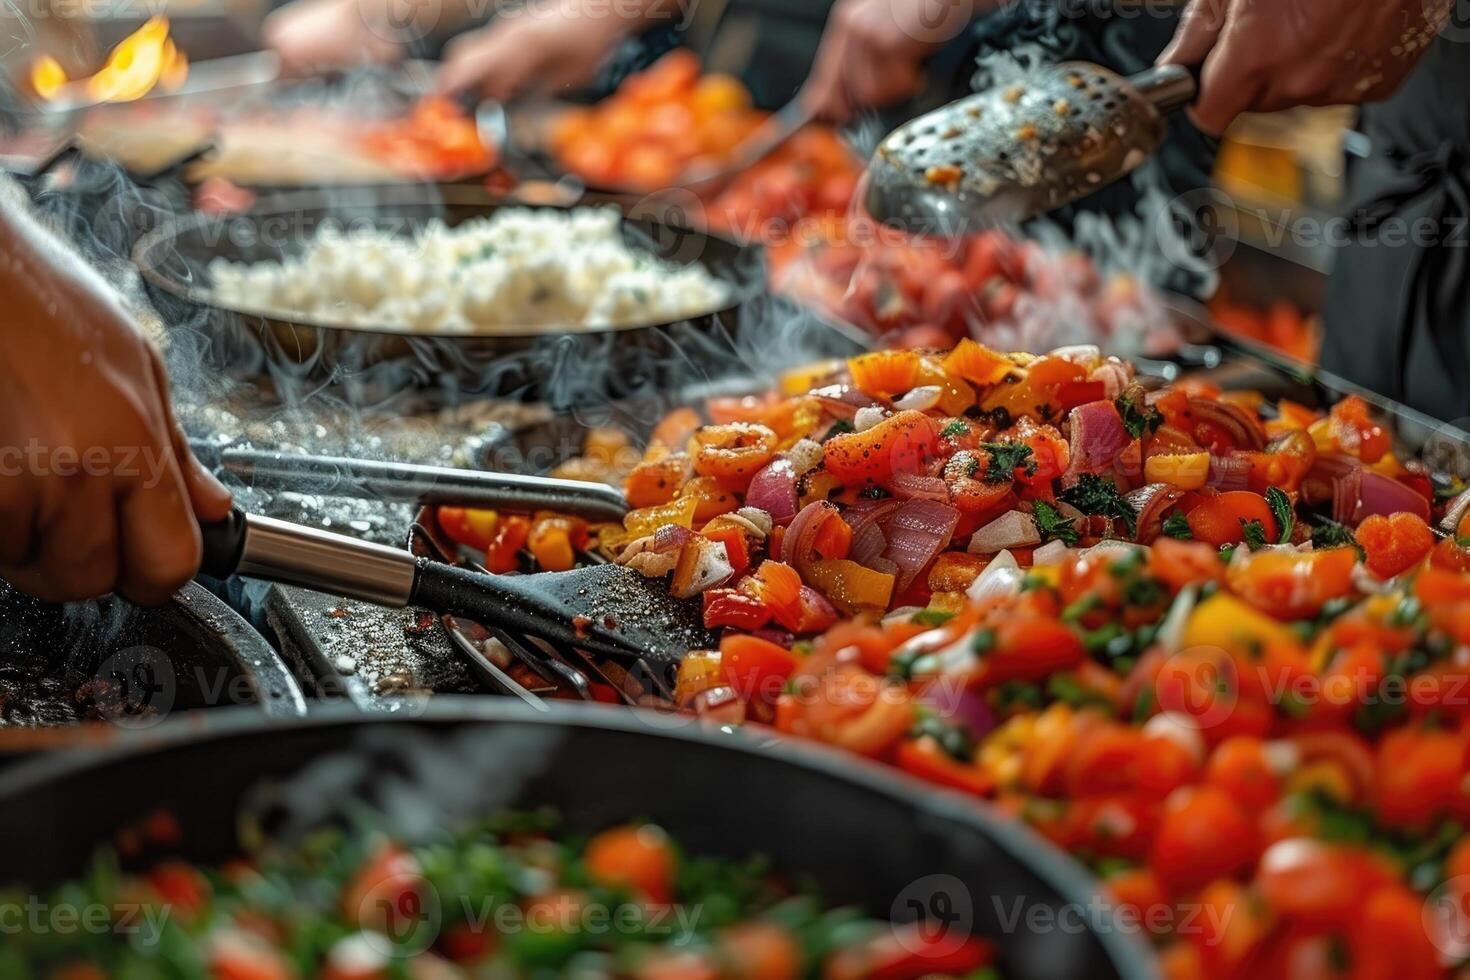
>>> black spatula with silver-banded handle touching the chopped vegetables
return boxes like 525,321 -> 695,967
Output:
201,507 -> 711,667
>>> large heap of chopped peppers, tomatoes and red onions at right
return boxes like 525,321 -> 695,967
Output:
438,341 -> 1470,979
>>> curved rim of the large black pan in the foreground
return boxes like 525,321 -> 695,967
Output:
0,695 -> 1160,977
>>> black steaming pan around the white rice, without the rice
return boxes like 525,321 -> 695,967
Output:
134,187 -> 772,406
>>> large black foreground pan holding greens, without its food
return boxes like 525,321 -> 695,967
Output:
0,699 -> 1157,980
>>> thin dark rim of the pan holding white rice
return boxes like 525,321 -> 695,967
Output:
132,184 -> 764,344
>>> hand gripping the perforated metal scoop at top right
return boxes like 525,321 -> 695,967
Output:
1158,0 -> 1454,135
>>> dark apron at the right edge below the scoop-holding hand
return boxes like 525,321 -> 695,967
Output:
1322,38 -> 1470,422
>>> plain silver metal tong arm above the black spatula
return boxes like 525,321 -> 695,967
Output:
218,448 -> 628,520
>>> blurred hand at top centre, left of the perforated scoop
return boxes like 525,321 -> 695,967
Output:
801,0 -> 975,122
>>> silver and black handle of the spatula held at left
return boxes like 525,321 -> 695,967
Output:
200,507 -> 417,607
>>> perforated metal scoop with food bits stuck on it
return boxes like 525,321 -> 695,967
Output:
864,62 -> 1197,235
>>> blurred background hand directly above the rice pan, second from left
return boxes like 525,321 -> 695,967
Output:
435,4 -> 641,101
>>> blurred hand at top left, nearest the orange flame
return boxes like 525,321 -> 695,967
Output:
260,0 -> 403,75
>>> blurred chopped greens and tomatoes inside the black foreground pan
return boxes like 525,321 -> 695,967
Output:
0,813 -> 1000,980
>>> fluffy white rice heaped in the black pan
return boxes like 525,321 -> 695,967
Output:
209,207 -> 729,332
